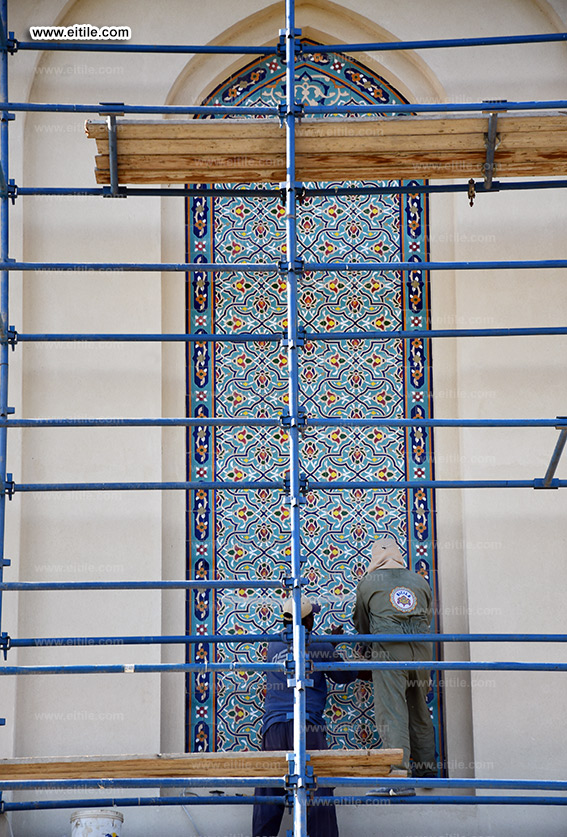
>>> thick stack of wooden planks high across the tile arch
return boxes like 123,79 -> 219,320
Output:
86,113 -> 567,184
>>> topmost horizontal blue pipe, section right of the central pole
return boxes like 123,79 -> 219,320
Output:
299,32 -> 567,55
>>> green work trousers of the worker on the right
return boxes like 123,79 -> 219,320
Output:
372,642 -> 437,777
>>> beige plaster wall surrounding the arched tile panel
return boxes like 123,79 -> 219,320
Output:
0,0 -> 567,837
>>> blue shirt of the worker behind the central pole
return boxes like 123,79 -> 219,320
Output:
262,642 -> 357,734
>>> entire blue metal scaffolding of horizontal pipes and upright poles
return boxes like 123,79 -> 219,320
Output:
0,0 -> 567,837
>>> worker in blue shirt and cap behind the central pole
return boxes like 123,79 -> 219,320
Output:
252,596 -> 358,837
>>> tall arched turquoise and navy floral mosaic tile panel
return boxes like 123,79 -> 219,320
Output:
186,45 -> 444,758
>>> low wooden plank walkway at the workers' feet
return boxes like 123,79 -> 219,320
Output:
0,750 -> 403,781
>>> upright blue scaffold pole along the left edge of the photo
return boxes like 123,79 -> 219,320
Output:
0,0 -> 10,648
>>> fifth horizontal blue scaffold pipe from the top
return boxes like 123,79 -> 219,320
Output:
10,326 -> 567,343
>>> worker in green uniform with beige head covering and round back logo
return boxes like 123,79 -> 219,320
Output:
353,538 -> 437,795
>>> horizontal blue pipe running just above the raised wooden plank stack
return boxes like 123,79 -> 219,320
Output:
6,99 -> 567,117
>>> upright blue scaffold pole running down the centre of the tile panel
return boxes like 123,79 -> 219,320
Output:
285,0 -> 307,837
